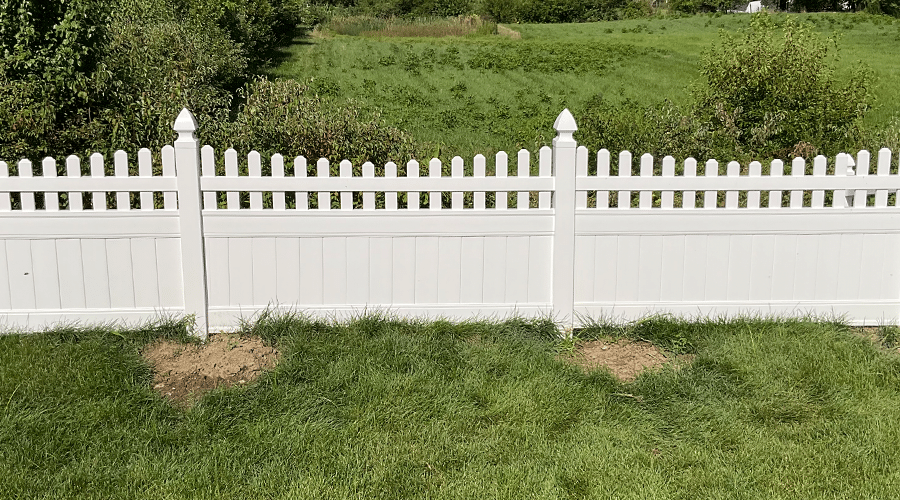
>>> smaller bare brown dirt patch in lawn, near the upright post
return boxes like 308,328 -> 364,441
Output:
566,339 -> 694,382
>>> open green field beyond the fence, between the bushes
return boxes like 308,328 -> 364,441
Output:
271,14 -> 900,156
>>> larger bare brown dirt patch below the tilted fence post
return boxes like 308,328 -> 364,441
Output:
143,333 -> 279,405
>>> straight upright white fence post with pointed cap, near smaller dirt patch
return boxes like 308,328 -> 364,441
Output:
552,109 -> 578,334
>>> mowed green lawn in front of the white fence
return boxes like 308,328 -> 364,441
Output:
0,317 -> 900,499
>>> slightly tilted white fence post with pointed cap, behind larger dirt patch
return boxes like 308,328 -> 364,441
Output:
173,108 -> 209,340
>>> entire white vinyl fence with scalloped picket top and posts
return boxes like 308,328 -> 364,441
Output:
0,110 -> 900,336
